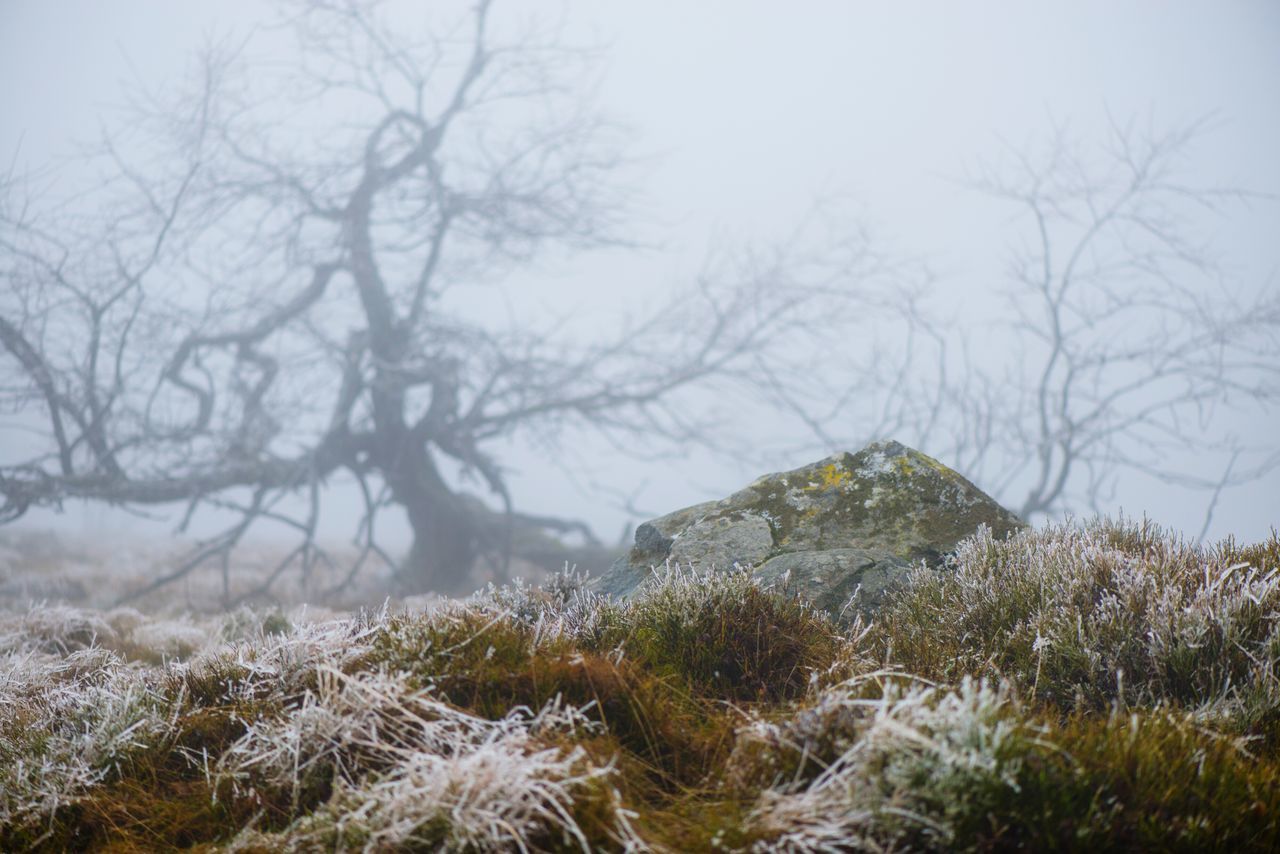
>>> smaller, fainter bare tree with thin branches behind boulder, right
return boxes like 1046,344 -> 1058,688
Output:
776,117 -> 1280,524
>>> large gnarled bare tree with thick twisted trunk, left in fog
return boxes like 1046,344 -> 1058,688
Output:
0,0 -> 869,601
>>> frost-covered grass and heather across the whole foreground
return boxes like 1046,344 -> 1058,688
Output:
0,521 -> 1280,851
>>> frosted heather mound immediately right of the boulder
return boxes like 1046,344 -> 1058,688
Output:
878,520 -> 1280,723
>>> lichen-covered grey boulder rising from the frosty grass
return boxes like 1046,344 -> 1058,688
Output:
596,442 -> 1023,612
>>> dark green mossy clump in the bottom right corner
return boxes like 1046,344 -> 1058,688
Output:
956,712 -> 1280,851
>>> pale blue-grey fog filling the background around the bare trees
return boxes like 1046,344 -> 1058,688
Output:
0,0 -> 1280,594
